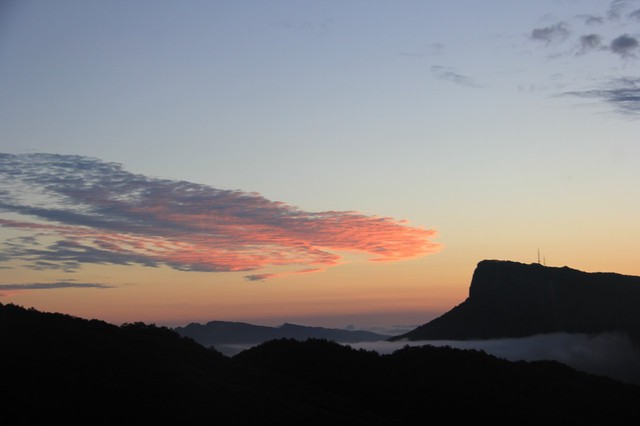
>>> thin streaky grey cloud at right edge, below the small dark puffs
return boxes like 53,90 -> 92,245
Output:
563,77 -> 640,118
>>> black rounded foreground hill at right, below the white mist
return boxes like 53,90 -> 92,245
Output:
234,339 -> 640,425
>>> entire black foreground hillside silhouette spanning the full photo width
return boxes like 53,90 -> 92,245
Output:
0,304 -> 640,425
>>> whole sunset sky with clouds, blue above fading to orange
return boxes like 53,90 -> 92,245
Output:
0,0 -> 640,332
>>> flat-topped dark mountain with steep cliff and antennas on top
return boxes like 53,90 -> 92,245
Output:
394,260 -> 640,340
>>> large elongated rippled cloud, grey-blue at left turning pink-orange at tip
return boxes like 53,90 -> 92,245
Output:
0,154 -> 441,280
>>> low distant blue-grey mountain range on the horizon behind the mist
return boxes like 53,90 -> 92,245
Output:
174,321 -> 391,353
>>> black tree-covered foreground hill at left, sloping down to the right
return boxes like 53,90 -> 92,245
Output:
0,304 -> 368,425
